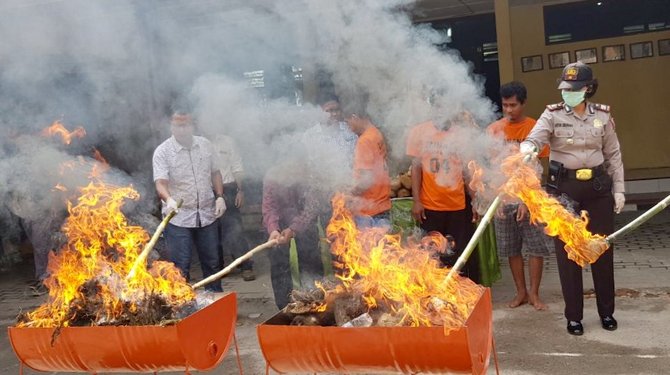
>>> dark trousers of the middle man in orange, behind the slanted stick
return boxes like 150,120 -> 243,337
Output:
421,207 -> 480,283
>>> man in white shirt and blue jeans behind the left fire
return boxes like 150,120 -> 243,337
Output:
153,113 -> 226,292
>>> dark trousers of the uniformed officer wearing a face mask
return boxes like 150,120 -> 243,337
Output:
552,176 -> 614,320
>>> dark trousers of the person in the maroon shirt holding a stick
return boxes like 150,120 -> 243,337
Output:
269,231 -> 323,310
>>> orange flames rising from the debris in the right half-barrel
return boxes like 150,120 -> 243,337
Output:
322,194 -> 483,330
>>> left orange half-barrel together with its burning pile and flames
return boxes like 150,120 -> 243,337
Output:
9,181 -> 242,373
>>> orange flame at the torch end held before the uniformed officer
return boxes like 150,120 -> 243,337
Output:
501,155 -> 609,267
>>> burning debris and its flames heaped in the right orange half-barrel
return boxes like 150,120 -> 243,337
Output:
283,195 -> 484,330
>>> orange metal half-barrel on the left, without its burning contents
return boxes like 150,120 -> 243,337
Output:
9,293 -> 237,373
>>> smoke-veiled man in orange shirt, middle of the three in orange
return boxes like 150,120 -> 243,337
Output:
406,104 -> 479,283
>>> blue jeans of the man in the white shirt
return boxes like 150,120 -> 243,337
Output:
165,221 -> 223,292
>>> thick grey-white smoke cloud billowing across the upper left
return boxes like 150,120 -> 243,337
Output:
0,0 -> 516,250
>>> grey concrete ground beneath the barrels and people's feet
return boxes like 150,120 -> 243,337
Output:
0,210 -> 670,375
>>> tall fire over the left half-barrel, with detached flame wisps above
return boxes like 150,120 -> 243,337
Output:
17,127 -> 195,327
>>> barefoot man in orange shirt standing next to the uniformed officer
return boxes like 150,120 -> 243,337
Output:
488,82 -> 552,310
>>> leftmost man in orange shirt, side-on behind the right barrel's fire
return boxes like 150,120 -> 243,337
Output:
345,101 -> 391,228
